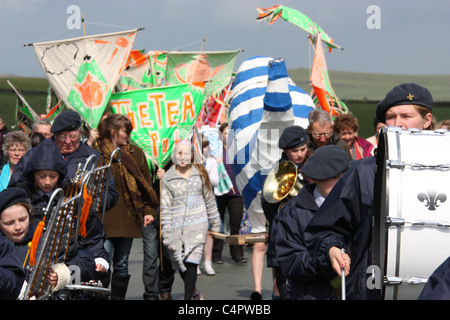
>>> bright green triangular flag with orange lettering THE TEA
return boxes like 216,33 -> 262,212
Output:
110,83 -> 203,168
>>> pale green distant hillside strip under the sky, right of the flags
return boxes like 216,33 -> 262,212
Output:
288,68 -> 450,102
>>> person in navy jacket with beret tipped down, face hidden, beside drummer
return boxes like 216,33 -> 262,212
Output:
274,145 -> 350,300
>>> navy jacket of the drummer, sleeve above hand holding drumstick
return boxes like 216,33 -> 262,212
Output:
305,157 -> 376,299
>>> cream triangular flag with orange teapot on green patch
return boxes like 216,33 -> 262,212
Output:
33,29 -> 138,128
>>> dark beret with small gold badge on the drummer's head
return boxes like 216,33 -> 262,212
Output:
376,83 -> 433,122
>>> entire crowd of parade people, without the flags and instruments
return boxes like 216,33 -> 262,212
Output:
0,83 -> 450,300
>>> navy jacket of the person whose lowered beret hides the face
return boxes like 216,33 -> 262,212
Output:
272,184 -> 336,300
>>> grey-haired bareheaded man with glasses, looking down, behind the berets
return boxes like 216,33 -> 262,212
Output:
308,109 -> 350,155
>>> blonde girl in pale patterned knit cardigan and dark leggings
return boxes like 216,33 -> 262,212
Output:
161,140 -> 221,300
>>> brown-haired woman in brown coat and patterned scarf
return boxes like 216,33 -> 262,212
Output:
94,114 -> 158,300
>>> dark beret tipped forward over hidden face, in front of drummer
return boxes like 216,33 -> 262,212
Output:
301,145 -> 350,180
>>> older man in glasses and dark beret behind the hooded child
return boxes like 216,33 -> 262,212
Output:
8,110 -> 118,280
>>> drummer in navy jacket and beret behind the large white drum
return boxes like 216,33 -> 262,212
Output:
305,83 -> 436,299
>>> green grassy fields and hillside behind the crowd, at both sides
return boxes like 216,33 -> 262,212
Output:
0,74 -> 450,138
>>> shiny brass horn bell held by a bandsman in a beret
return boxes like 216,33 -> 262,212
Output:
262,161 -> 301,203
